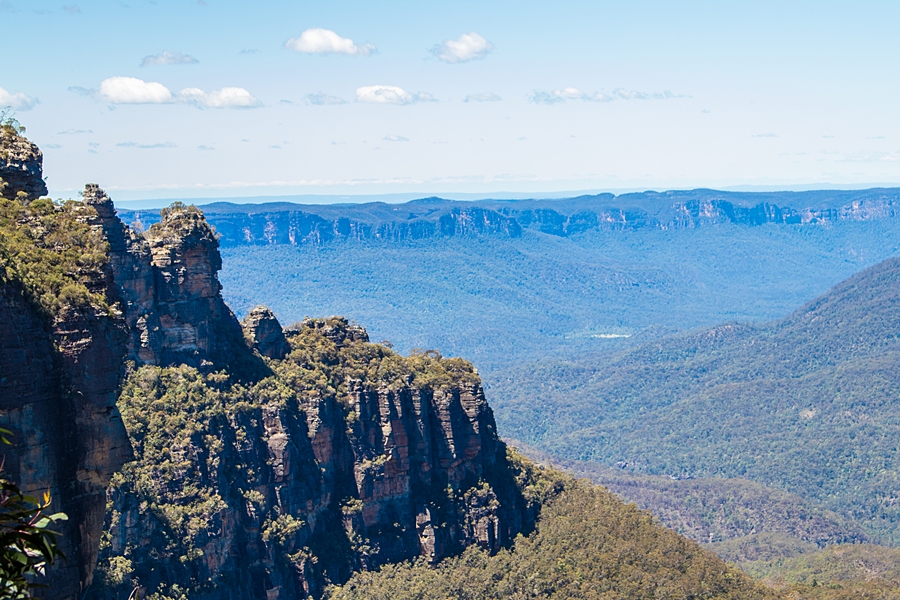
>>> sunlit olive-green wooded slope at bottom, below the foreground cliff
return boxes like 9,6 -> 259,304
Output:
328,481 -> 779,600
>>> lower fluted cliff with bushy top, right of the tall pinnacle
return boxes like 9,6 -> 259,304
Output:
95,318 -> 536,599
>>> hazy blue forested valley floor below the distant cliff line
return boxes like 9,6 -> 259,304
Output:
214,219 -> 900,372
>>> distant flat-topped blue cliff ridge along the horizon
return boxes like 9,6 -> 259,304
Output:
119,188 -> 900,247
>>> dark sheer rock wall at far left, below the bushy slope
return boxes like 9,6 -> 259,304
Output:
0,236 -> 132,598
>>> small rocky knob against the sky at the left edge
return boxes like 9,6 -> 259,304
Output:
0,124 -> 47,200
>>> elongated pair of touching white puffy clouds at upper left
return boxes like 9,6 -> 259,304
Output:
91,77 -> 262,108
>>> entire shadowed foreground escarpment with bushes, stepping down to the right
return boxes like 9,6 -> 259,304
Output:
0,179 -> 537,600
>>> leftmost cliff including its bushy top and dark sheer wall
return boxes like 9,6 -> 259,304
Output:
0,200 -> 131,598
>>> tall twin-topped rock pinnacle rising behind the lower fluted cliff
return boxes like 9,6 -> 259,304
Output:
83,184 -> 263,374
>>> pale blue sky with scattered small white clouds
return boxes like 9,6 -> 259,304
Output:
0,0 -> 900,201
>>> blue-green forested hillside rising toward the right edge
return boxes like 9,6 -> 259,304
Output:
498,259 -> 900,542
